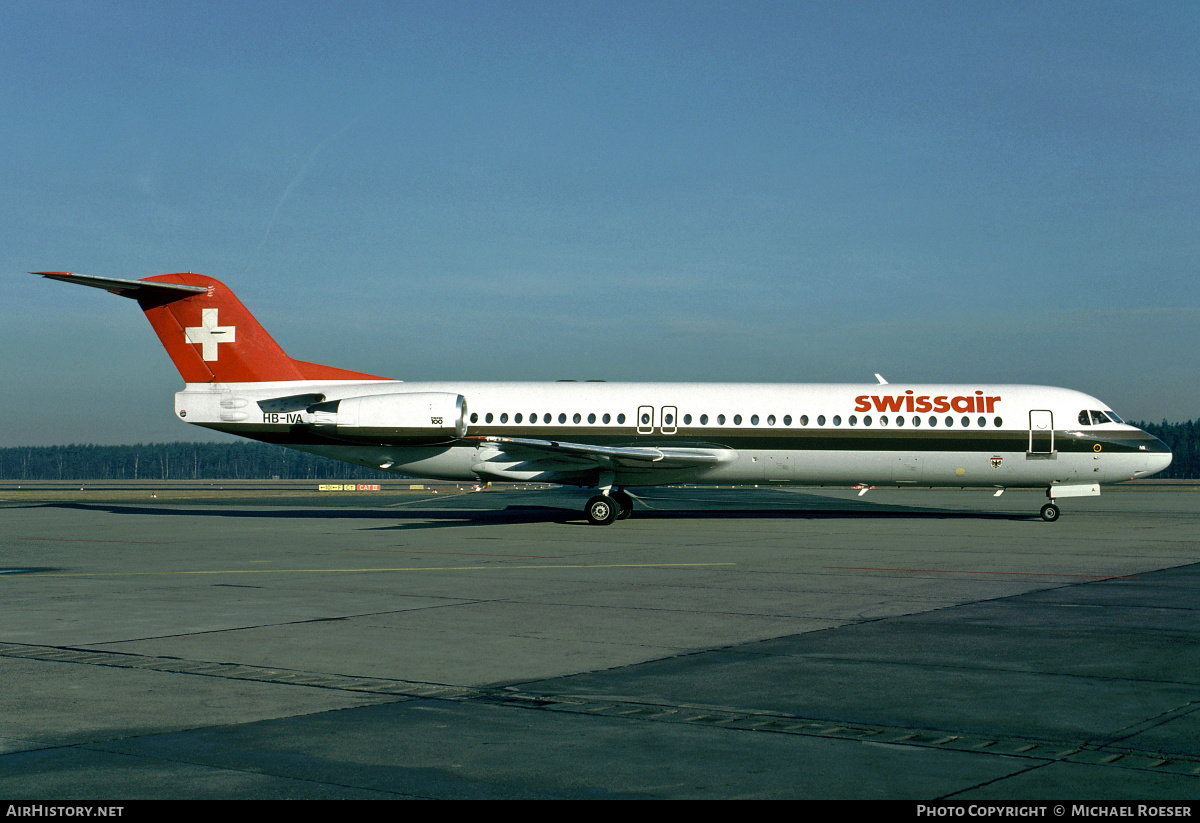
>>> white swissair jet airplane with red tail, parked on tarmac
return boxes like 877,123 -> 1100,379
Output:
30,271 -> 1172,525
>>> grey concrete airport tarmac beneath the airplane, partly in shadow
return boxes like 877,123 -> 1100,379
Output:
0,483 -> 1200,801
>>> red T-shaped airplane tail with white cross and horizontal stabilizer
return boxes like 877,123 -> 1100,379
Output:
34,271 -> 386,383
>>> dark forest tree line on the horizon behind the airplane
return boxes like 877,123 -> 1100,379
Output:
0,420 -> 1200,480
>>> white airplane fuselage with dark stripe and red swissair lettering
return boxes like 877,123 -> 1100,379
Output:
175,380 -> 1171,493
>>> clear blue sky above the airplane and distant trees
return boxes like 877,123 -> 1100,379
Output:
0,0 -> 1200,445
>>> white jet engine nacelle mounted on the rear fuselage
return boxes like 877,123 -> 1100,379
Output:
307,391 -> 467,438
